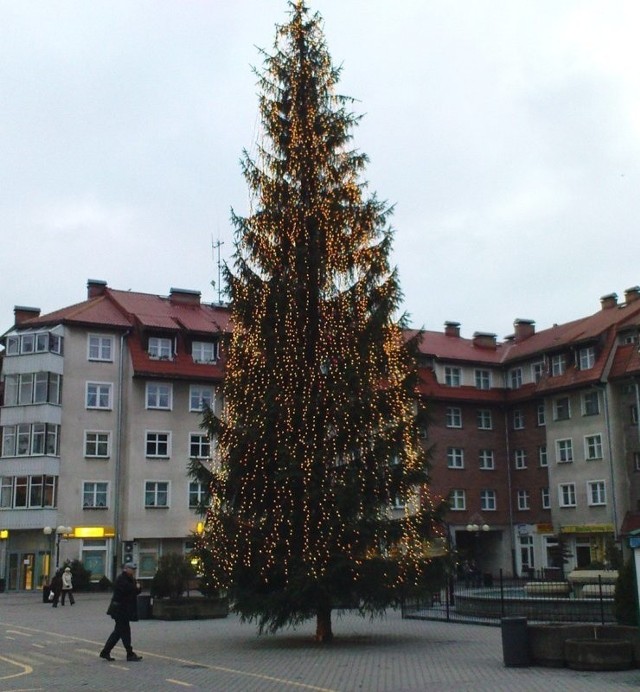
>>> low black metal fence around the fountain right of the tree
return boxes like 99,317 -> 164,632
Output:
402,572 -> 615,625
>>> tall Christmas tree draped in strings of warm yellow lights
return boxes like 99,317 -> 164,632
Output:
200,0 -> 442,641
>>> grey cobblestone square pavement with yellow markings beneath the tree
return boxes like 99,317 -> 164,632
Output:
0,593 -> 640,692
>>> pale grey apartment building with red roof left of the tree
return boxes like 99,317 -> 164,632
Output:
0,280 -> 229,589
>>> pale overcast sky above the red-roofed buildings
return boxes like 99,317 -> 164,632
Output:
0,0 -> 640,338
